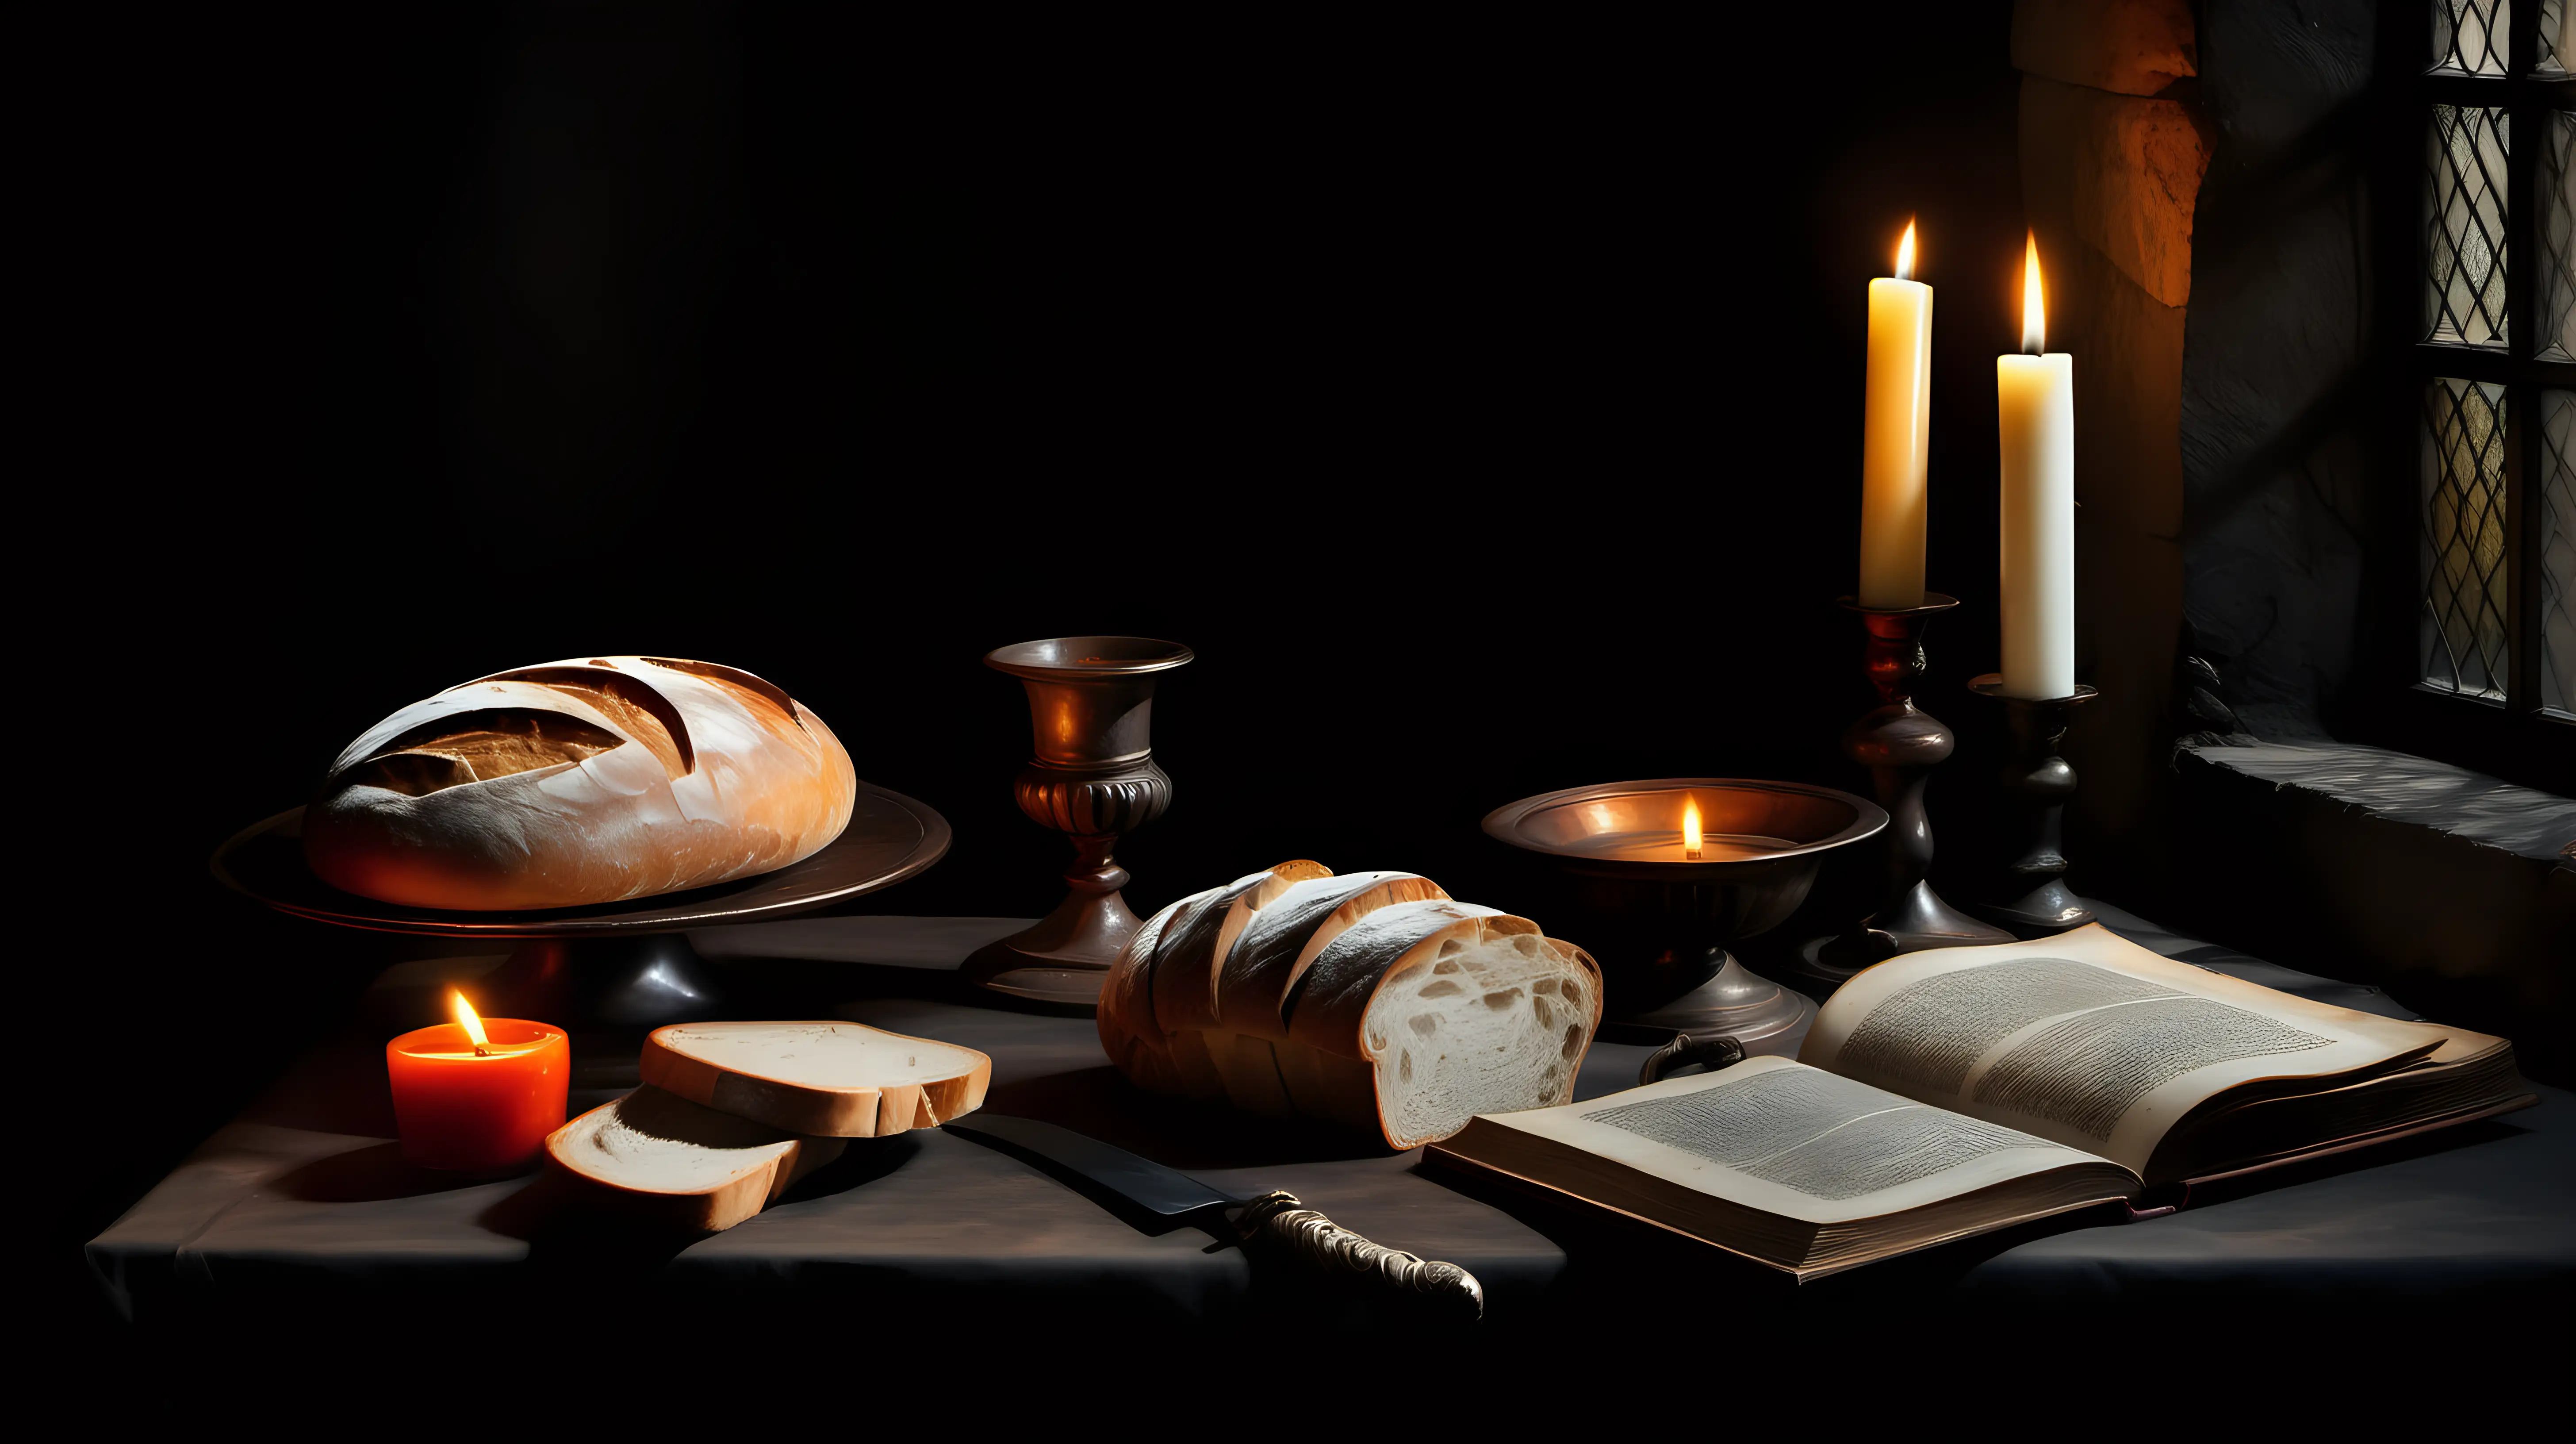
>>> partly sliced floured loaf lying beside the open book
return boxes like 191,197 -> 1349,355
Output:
1100,861 -> 1602,1148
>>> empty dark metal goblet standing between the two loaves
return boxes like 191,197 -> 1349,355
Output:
961,637 -> 1193,1011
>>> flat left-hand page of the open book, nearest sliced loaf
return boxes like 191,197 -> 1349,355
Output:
1484,1057 -> 2089,1222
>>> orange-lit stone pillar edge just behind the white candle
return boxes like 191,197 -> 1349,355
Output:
2012,0 -> 2210,902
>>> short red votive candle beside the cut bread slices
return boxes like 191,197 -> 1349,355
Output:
384,1018 -> 572,1173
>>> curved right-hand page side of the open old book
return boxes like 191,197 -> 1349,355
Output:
1798,923 -> 2445,1171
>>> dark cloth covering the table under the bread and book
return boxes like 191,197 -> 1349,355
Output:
88,915 -> 2576,1402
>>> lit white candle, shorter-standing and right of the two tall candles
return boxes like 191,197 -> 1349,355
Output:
1994,237 -> 2076,696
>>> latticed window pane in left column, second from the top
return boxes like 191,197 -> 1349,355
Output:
2424,106 -> 2509,348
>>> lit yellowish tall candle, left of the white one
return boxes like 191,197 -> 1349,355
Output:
1860,222 -> 1932,609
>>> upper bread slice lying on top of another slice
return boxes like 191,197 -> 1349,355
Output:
641,1021 -> 992,1137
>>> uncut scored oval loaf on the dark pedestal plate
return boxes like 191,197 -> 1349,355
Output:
304,657 -> 858,913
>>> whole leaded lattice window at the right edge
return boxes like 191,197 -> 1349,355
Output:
2414,0 -> 2576,719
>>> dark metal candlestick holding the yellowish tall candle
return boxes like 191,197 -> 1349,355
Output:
1798,591 -> 2012,993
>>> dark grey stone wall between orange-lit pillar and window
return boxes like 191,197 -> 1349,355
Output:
2182,0 -> 2414,743
